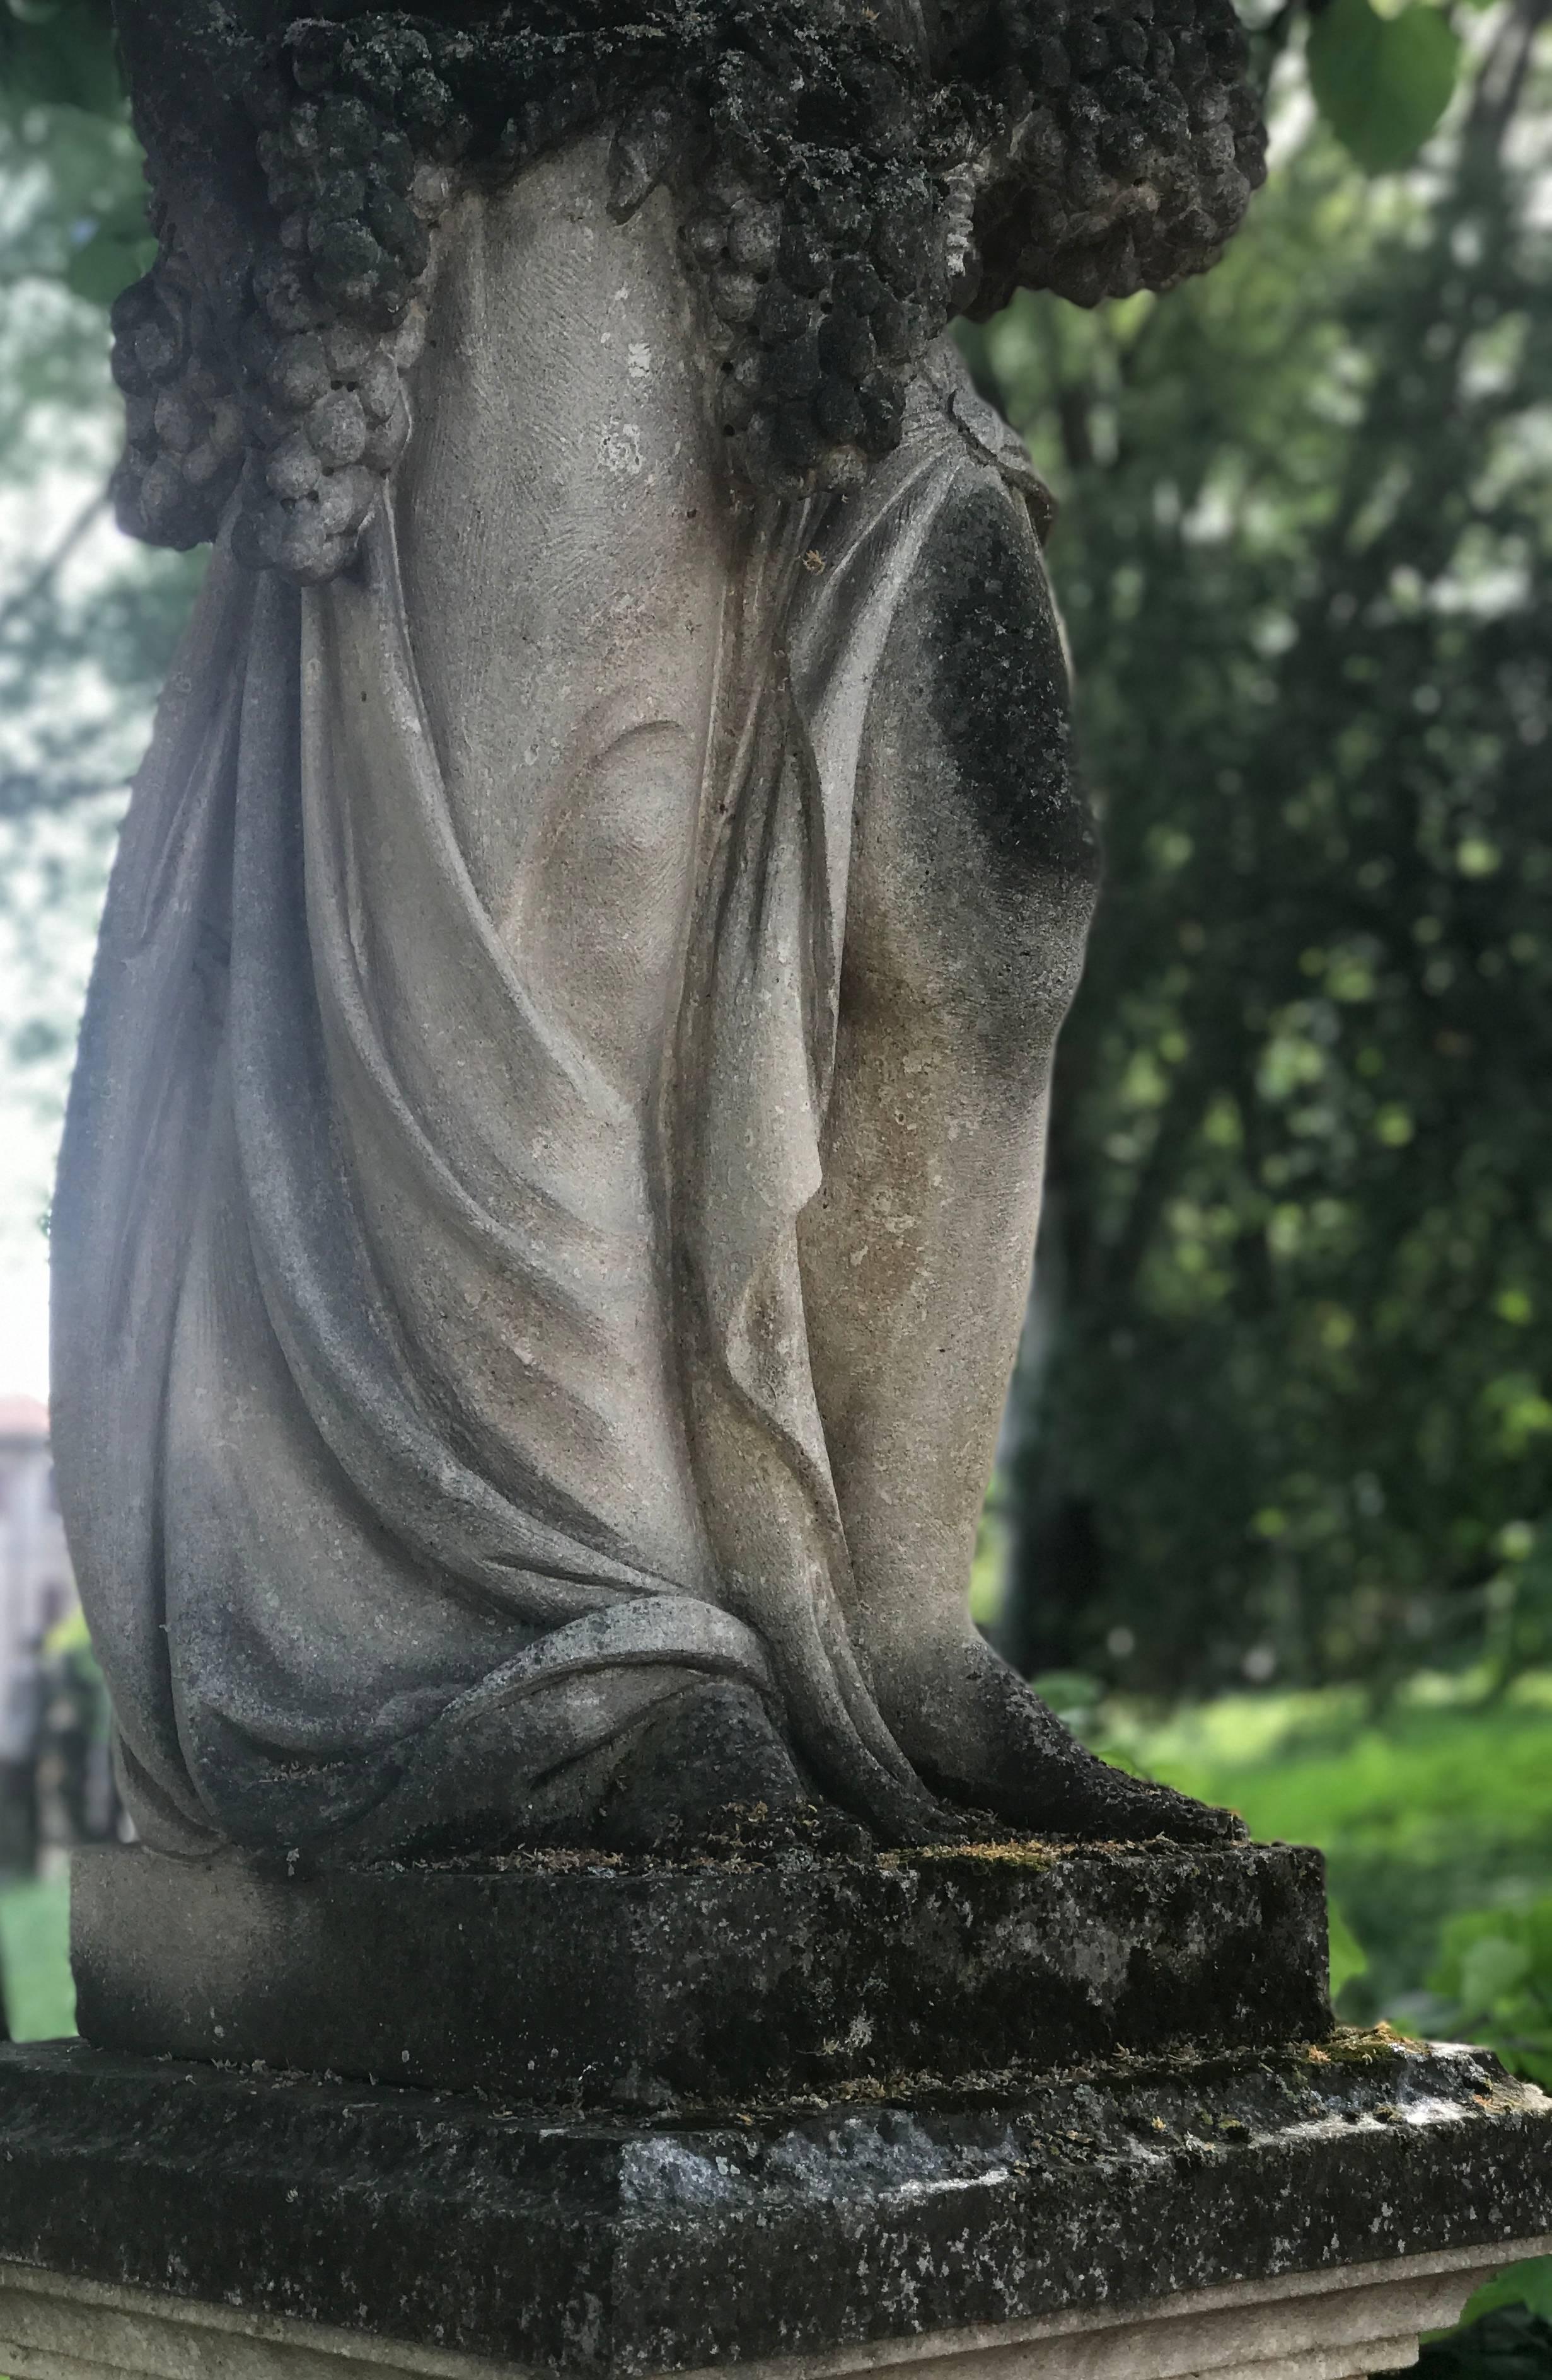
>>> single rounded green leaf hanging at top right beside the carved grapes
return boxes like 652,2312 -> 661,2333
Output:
1309,0 -> 1462,174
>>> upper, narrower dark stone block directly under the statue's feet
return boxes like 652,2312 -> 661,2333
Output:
74,1844 -> 1331,2106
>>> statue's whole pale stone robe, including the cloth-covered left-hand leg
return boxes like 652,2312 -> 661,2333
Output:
55,136 -> 1066,1852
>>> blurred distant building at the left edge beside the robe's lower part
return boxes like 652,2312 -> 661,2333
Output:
0,1397 -> 76,1764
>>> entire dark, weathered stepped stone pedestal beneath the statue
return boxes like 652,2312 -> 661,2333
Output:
0,1844 -> 1552,2380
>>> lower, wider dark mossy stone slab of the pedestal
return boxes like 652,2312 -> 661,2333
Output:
0,2035 -> 1552,2375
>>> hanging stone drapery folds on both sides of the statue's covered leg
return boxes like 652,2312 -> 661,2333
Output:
55,321 -> 1004,1852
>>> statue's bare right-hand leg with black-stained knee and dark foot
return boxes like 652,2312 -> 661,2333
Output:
800,471 -> 1233,1837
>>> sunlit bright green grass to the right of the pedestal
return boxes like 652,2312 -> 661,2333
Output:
1104,1673 -> 1552,2380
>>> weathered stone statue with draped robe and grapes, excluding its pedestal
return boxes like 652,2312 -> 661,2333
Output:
55,0 -> 1264,1864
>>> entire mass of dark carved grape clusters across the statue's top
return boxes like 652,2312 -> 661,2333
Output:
114,0 -> 1264,586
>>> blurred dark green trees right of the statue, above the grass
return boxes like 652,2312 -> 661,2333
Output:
990,7 -> 1552,1699
